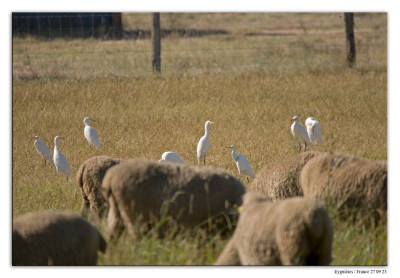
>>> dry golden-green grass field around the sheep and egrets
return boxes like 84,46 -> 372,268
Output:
12,11 -> 388,265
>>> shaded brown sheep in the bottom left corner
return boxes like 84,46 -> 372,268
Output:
12,211 -> 107,266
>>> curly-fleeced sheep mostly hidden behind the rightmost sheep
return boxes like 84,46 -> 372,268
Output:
249,152 -> 321,200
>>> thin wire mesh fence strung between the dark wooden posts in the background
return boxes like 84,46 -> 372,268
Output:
12,13 -> 387,80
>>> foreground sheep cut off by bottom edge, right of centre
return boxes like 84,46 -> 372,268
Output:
215,191 -> 333,265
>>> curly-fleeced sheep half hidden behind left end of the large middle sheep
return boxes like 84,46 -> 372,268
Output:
76,156 -> 123,216
